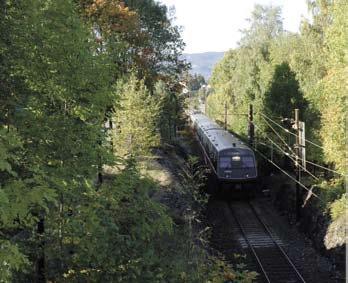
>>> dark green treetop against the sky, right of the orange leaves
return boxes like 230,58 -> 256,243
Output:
125,0 -> 188,86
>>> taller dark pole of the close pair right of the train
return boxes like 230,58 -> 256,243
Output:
294,109 -> 301,222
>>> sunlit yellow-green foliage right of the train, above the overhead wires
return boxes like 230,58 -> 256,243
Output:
208,1 -> 348,173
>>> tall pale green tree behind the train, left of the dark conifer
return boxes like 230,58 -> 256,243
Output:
208,5 -> 282,138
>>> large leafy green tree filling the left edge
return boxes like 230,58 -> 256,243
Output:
0,0 -> 113,281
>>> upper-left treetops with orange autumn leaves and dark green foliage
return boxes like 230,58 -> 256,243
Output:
78,0 -> 187,91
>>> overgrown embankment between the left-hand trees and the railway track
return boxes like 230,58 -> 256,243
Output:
141,143 -> 256,283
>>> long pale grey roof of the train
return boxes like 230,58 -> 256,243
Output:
191,113 -> 250,151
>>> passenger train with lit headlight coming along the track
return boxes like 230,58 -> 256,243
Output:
189,110 -> 258,192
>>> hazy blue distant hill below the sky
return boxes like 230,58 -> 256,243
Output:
183,52 -> 225,79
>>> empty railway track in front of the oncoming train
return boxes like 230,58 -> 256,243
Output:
229,202 -> 306,283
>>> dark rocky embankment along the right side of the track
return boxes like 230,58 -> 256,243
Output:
263,175 -> 346,280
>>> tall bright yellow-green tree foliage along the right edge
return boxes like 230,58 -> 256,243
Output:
318,1 -> 348,173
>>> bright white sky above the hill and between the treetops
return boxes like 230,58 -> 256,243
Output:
159,0 -> 309,53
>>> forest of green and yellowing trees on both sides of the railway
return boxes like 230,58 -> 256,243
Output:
0,0 -> 348,283
